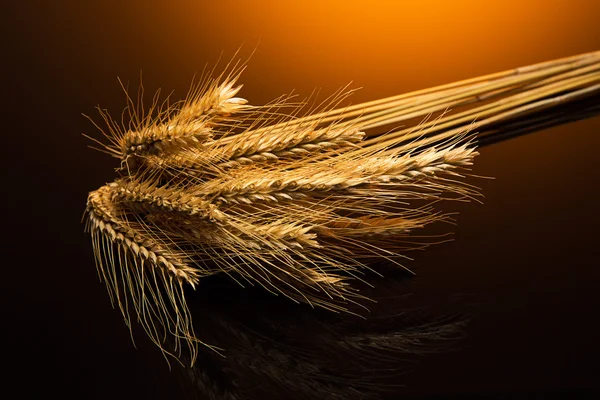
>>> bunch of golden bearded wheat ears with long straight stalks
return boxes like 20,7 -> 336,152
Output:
87,53 -> 600,362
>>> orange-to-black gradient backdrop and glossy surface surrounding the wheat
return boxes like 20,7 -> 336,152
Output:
2,2 -> 600,399
